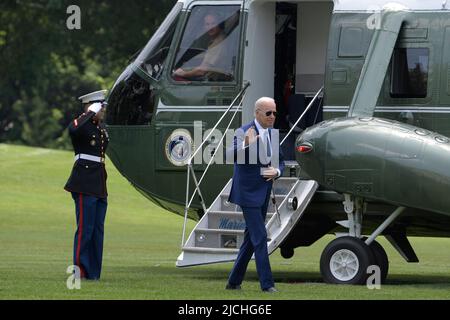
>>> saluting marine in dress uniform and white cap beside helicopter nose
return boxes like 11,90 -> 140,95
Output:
64,90 -> 109,280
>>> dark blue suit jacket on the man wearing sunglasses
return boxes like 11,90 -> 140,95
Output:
228,121 -> 284,207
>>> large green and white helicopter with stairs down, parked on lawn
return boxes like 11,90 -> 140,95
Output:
106,0 -> 450,284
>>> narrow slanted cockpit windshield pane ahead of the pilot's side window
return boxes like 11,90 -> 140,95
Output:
136,2 -> 183,80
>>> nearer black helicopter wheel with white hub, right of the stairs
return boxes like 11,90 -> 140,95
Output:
320,236 -> 375,284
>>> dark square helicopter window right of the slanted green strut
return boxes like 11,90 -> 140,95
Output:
391,48 -> 429,98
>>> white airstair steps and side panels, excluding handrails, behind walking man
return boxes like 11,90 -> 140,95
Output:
176,177 -> 318,267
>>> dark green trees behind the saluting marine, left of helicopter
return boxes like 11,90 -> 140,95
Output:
0,0 -> 176,148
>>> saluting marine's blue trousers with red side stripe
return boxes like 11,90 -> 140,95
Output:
72,192 -> 108,280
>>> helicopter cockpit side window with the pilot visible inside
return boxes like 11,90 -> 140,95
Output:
172,5 -> 240,82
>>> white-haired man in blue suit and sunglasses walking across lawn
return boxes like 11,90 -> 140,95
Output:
226,97 -> 284,292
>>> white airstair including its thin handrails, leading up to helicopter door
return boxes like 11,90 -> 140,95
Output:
176,82 -> 323,267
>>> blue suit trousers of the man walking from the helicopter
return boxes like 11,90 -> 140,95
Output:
228,190 -> 274,290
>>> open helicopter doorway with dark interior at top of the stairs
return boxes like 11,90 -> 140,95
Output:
274,1 -> 333,160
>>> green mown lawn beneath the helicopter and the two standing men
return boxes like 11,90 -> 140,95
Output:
0,144 -> 450,300
